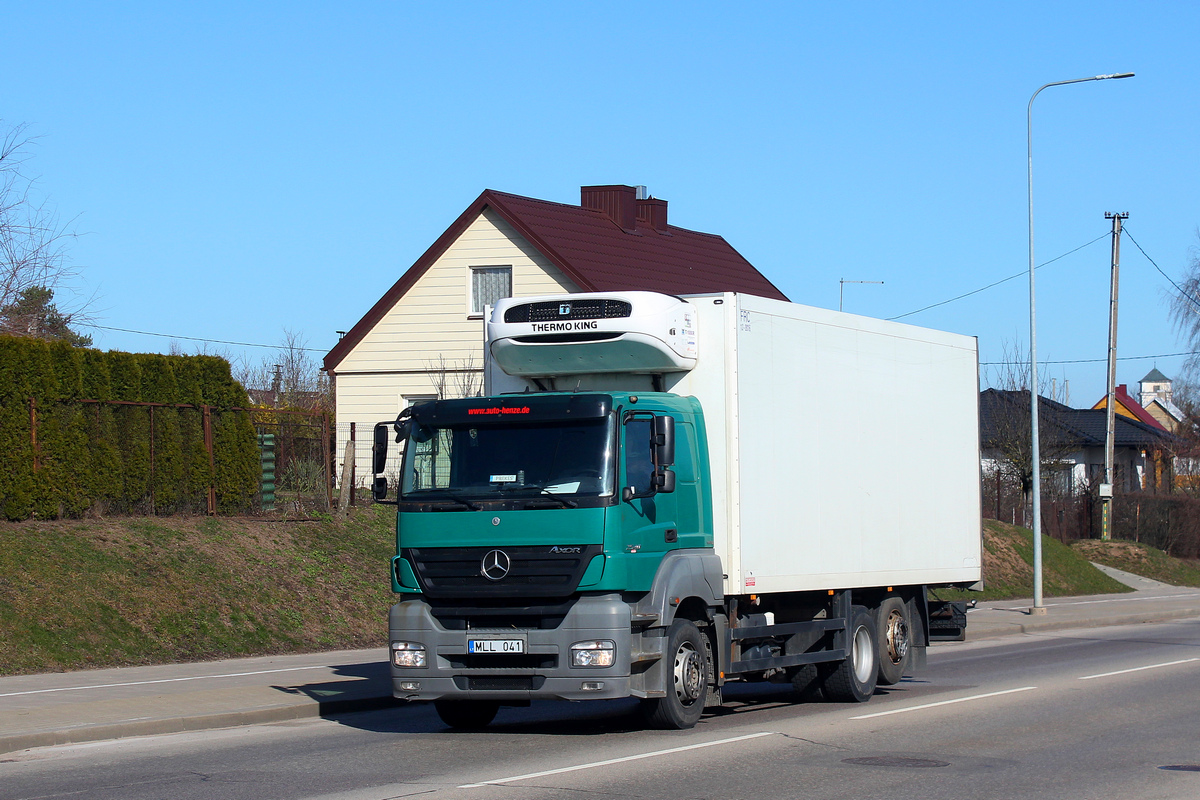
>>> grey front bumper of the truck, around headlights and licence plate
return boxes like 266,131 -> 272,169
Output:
389,594 -> 631,703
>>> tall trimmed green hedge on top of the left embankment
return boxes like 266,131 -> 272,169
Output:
0,336 -> 259,519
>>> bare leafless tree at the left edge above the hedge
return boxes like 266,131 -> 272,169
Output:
0,125 -> 91,344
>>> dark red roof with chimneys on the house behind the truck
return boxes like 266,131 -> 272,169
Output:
323,186 -> 787,369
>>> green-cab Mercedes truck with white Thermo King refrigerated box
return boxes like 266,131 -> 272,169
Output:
373,291 -> 982,728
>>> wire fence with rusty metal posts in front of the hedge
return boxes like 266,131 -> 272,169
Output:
10,397 -> 335,519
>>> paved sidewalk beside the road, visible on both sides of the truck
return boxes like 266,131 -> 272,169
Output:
0,573 -> 1200,753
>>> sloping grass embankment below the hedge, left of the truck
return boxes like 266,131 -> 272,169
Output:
0,507 -> 395,674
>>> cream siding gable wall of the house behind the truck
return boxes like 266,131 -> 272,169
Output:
335,209 -> 580,486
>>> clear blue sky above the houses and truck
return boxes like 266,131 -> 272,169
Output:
0,1 -> 1200,405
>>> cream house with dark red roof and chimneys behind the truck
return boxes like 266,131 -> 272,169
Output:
323,186 -> 787,477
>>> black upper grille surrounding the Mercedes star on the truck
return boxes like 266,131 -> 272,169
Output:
402,545 -> 602,599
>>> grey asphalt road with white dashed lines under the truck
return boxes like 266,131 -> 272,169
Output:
0,620 -> 1200,800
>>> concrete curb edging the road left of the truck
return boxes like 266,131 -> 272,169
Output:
0,694 -> 398,754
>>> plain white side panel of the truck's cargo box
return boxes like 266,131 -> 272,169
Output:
691,295 -> 982,594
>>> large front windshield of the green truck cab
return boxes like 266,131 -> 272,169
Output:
401,415 -> 614,500
